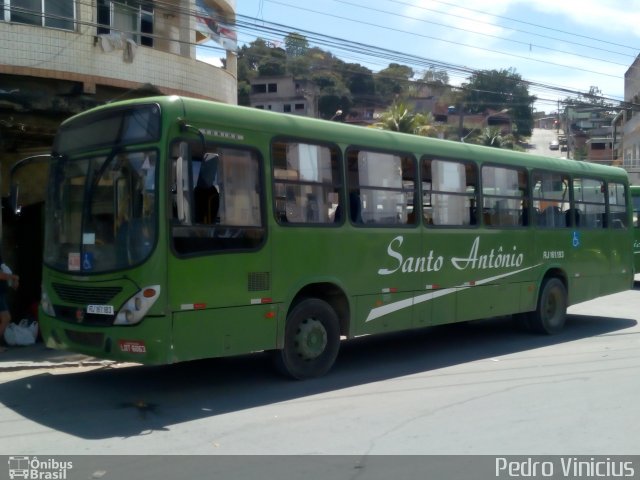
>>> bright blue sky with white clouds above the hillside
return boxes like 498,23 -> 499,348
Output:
198,0 -> 640,112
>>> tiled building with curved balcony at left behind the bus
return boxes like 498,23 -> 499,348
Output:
0,0 -> 237,318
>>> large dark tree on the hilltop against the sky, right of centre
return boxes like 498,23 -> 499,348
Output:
461,69 -> 536,137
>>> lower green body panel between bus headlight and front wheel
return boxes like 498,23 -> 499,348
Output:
173,305 -> 277,362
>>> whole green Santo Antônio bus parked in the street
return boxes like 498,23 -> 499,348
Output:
40,96 -> 633,379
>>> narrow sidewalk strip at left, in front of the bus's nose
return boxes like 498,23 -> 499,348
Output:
0,342 -> 113,373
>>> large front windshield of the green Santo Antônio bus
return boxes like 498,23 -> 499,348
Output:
44,149 -> 157,273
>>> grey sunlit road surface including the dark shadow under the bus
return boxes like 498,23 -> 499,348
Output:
0,289 -> 640,460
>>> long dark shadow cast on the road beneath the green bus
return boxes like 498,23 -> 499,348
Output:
0,315 -> 637,439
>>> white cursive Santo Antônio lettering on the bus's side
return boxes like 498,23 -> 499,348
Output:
378,235 -> 524,275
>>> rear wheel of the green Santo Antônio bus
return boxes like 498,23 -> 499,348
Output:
528,278 -> 567,335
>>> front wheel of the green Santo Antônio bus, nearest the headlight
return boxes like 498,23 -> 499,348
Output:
275,298 -> 340,380
